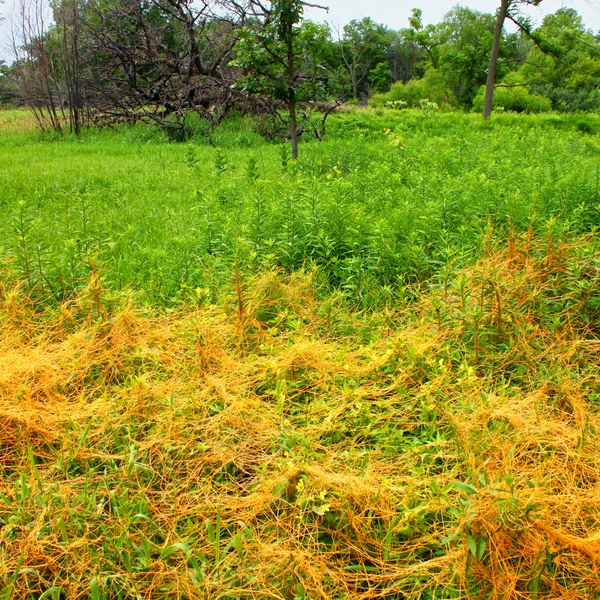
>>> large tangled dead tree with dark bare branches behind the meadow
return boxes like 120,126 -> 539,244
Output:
78,0 -> 253,129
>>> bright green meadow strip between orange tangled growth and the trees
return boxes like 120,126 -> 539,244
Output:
0,110 -> 600,309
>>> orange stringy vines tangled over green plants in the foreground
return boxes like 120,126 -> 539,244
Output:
0,231 -> 600,600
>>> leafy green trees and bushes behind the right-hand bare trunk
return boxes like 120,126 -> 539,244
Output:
374,6 -> 600,112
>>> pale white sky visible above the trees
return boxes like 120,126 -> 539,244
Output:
0,0 -> 600,60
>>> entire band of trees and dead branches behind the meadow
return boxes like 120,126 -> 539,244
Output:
0,0 -> 600,137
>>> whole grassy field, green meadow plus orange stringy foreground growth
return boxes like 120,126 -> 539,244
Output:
0,110 -> 600,600
